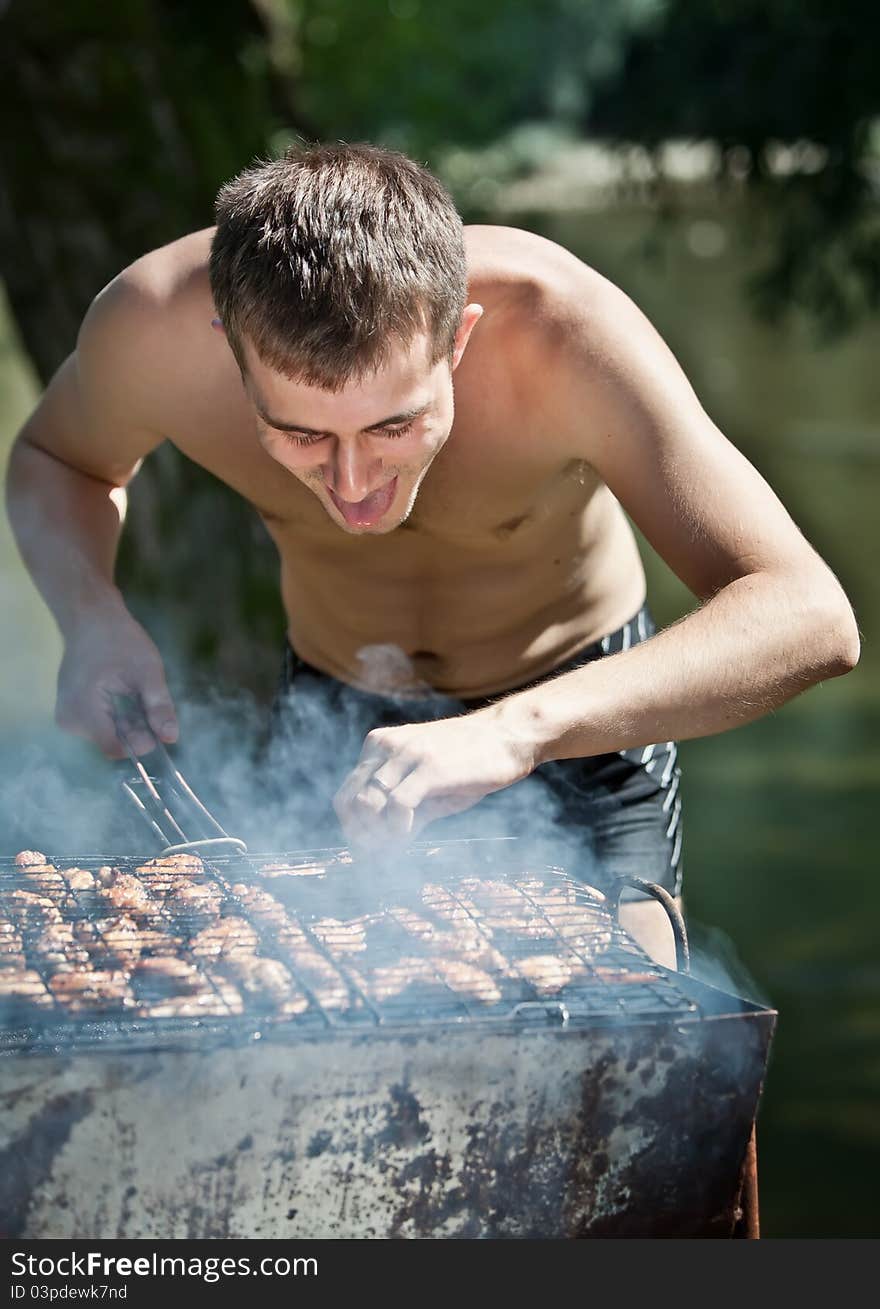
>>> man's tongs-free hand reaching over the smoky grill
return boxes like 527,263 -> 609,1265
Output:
334,707 -> 534,846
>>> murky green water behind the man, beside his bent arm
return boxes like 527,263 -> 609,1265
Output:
0,198 -> 880,1237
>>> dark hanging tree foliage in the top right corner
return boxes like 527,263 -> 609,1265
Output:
583,0 -> 880,334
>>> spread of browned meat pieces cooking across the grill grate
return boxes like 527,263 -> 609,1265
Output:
0,851 -> 623,1036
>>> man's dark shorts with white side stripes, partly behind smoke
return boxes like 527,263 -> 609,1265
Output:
270,605 -> 682,895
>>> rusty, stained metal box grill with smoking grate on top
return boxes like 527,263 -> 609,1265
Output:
0,843 -> 774,1238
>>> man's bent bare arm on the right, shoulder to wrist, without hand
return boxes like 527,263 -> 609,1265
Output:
495,287 -> 859,763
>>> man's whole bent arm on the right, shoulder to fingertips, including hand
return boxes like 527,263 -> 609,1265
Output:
337,281 -> 859,839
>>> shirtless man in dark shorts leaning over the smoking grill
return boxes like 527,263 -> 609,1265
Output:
9,145 -> 859,968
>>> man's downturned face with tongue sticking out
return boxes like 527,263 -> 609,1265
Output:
245,305 -> 482,535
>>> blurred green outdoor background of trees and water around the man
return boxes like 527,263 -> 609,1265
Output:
0,0 -> 880,1237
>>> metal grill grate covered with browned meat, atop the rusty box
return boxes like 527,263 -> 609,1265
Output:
0,842 -> 695,1051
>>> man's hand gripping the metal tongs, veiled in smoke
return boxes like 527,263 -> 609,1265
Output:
55,614 -> 177,759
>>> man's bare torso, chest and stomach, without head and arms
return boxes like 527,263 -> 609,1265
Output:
137,228 -> 644,698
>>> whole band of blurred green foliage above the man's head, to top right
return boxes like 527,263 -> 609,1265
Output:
276,0 -> 880,332
